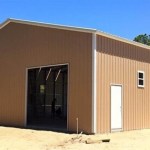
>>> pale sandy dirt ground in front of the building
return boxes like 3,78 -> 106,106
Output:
0,127 -> 150,150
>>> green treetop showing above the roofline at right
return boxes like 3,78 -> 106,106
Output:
133,34 -> 150,45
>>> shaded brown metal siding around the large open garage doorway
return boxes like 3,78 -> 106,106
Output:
0,23 -> 92,132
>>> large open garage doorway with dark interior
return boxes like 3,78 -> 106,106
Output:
27,65 -> 68,131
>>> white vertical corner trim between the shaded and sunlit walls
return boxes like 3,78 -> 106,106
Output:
92,33 -> 97,133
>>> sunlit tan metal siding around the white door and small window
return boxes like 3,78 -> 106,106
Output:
97,35 -> 150,133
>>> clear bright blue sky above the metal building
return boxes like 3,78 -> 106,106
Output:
0,0 -> 150,40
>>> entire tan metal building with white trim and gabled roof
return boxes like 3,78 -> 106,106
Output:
0,19 -> 150,133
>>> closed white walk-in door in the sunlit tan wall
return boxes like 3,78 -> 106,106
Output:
111,85 -> 122,131
